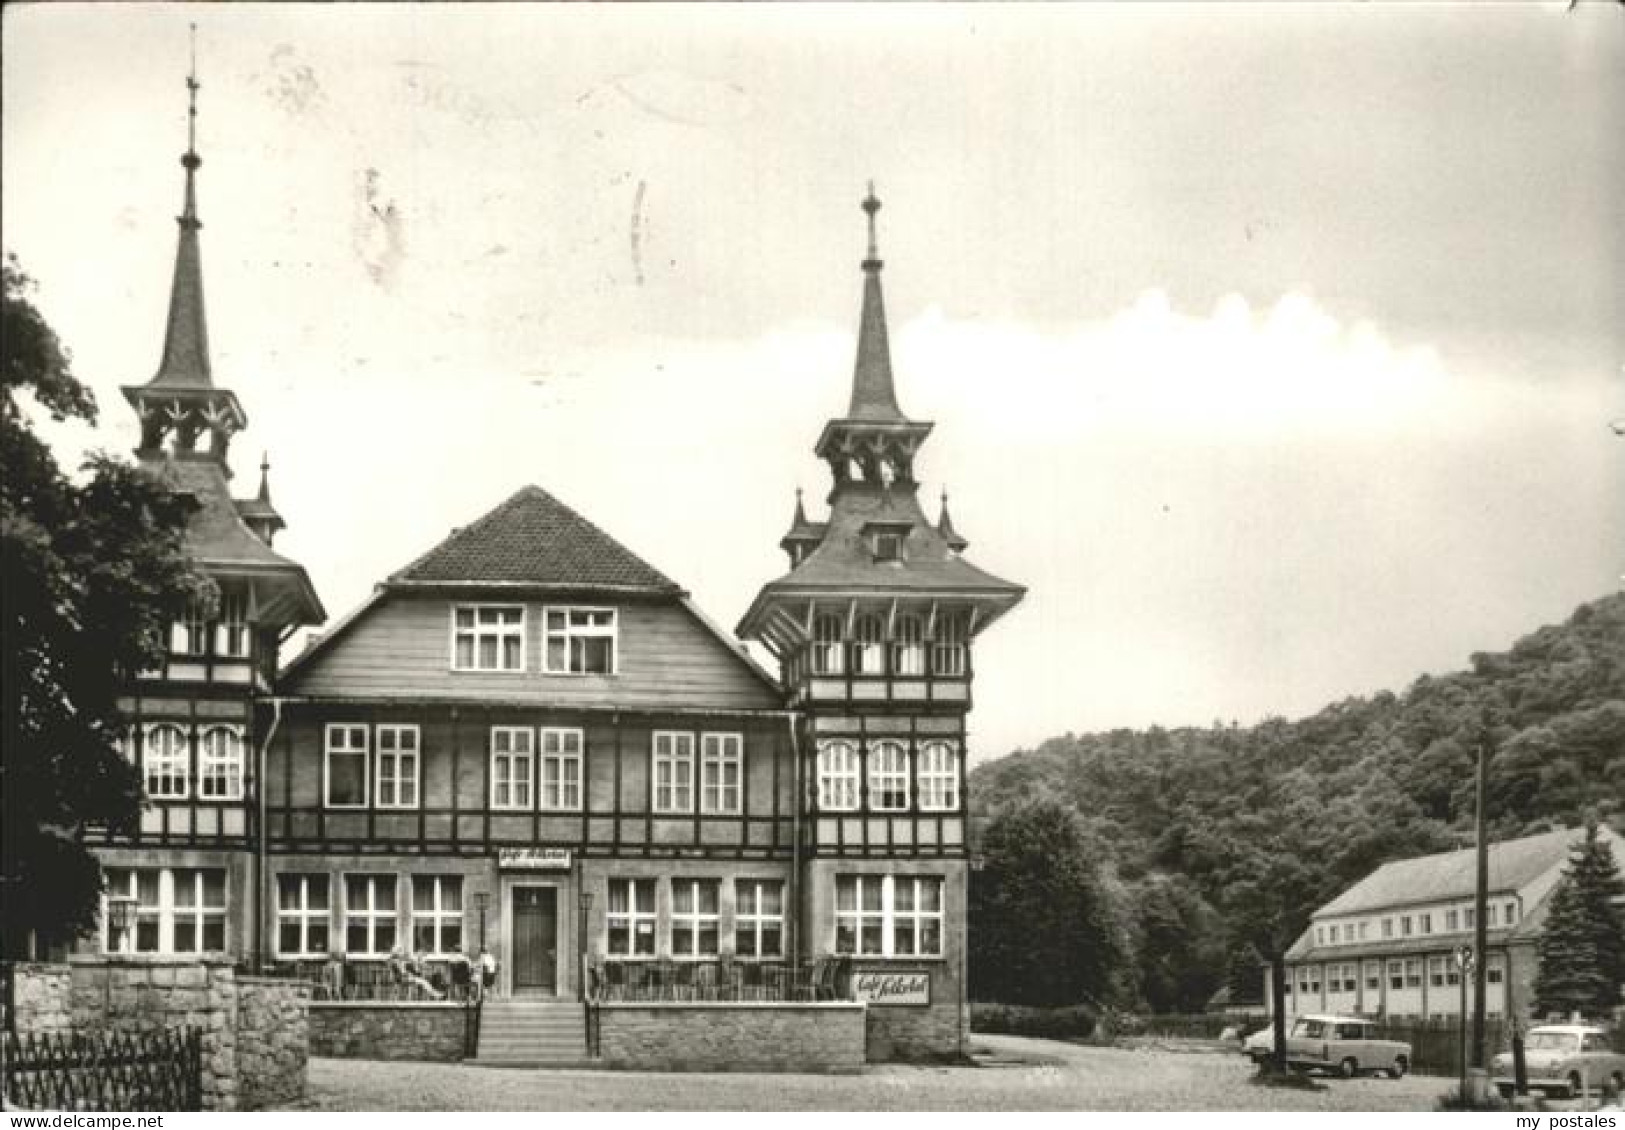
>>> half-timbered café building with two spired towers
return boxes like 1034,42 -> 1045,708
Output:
85,61 -> 1022,1057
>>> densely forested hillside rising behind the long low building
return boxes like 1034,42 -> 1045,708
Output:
970,593 -> 1625,901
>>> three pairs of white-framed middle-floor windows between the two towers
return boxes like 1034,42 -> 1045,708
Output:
323,722 -> 744,816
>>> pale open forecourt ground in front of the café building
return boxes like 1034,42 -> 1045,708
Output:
302,1034 -> 1454,1110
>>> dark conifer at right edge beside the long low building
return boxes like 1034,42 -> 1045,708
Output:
1534,819 -> 1625,1016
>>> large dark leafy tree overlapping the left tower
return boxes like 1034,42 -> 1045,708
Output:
0,255 -> 213,954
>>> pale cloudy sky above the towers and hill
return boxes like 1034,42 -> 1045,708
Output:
0,3 -> 1625,759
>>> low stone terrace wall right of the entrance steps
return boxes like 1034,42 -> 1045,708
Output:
596,1002 -> 866,1073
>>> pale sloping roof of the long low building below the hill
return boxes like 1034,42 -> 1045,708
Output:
1315,828 -> 1586,919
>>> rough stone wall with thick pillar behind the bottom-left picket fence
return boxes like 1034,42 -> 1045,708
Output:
13,956 -> 309,1110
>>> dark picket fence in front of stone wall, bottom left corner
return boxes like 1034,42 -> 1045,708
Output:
0,1028 -> 203,1110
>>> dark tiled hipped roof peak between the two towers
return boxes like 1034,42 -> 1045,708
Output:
390,486 -> 679,593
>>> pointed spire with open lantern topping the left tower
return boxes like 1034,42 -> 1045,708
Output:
124,24 -> 249,475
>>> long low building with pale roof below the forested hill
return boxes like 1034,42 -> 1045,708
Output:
1264,828 -> 1622,1019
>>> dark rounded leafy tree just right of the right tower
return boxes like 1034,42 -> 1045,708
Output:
970,800 -> 1125,1006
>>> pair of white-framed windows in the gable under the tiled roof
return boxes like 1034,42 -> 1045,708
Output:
452,605 -> 618,675
